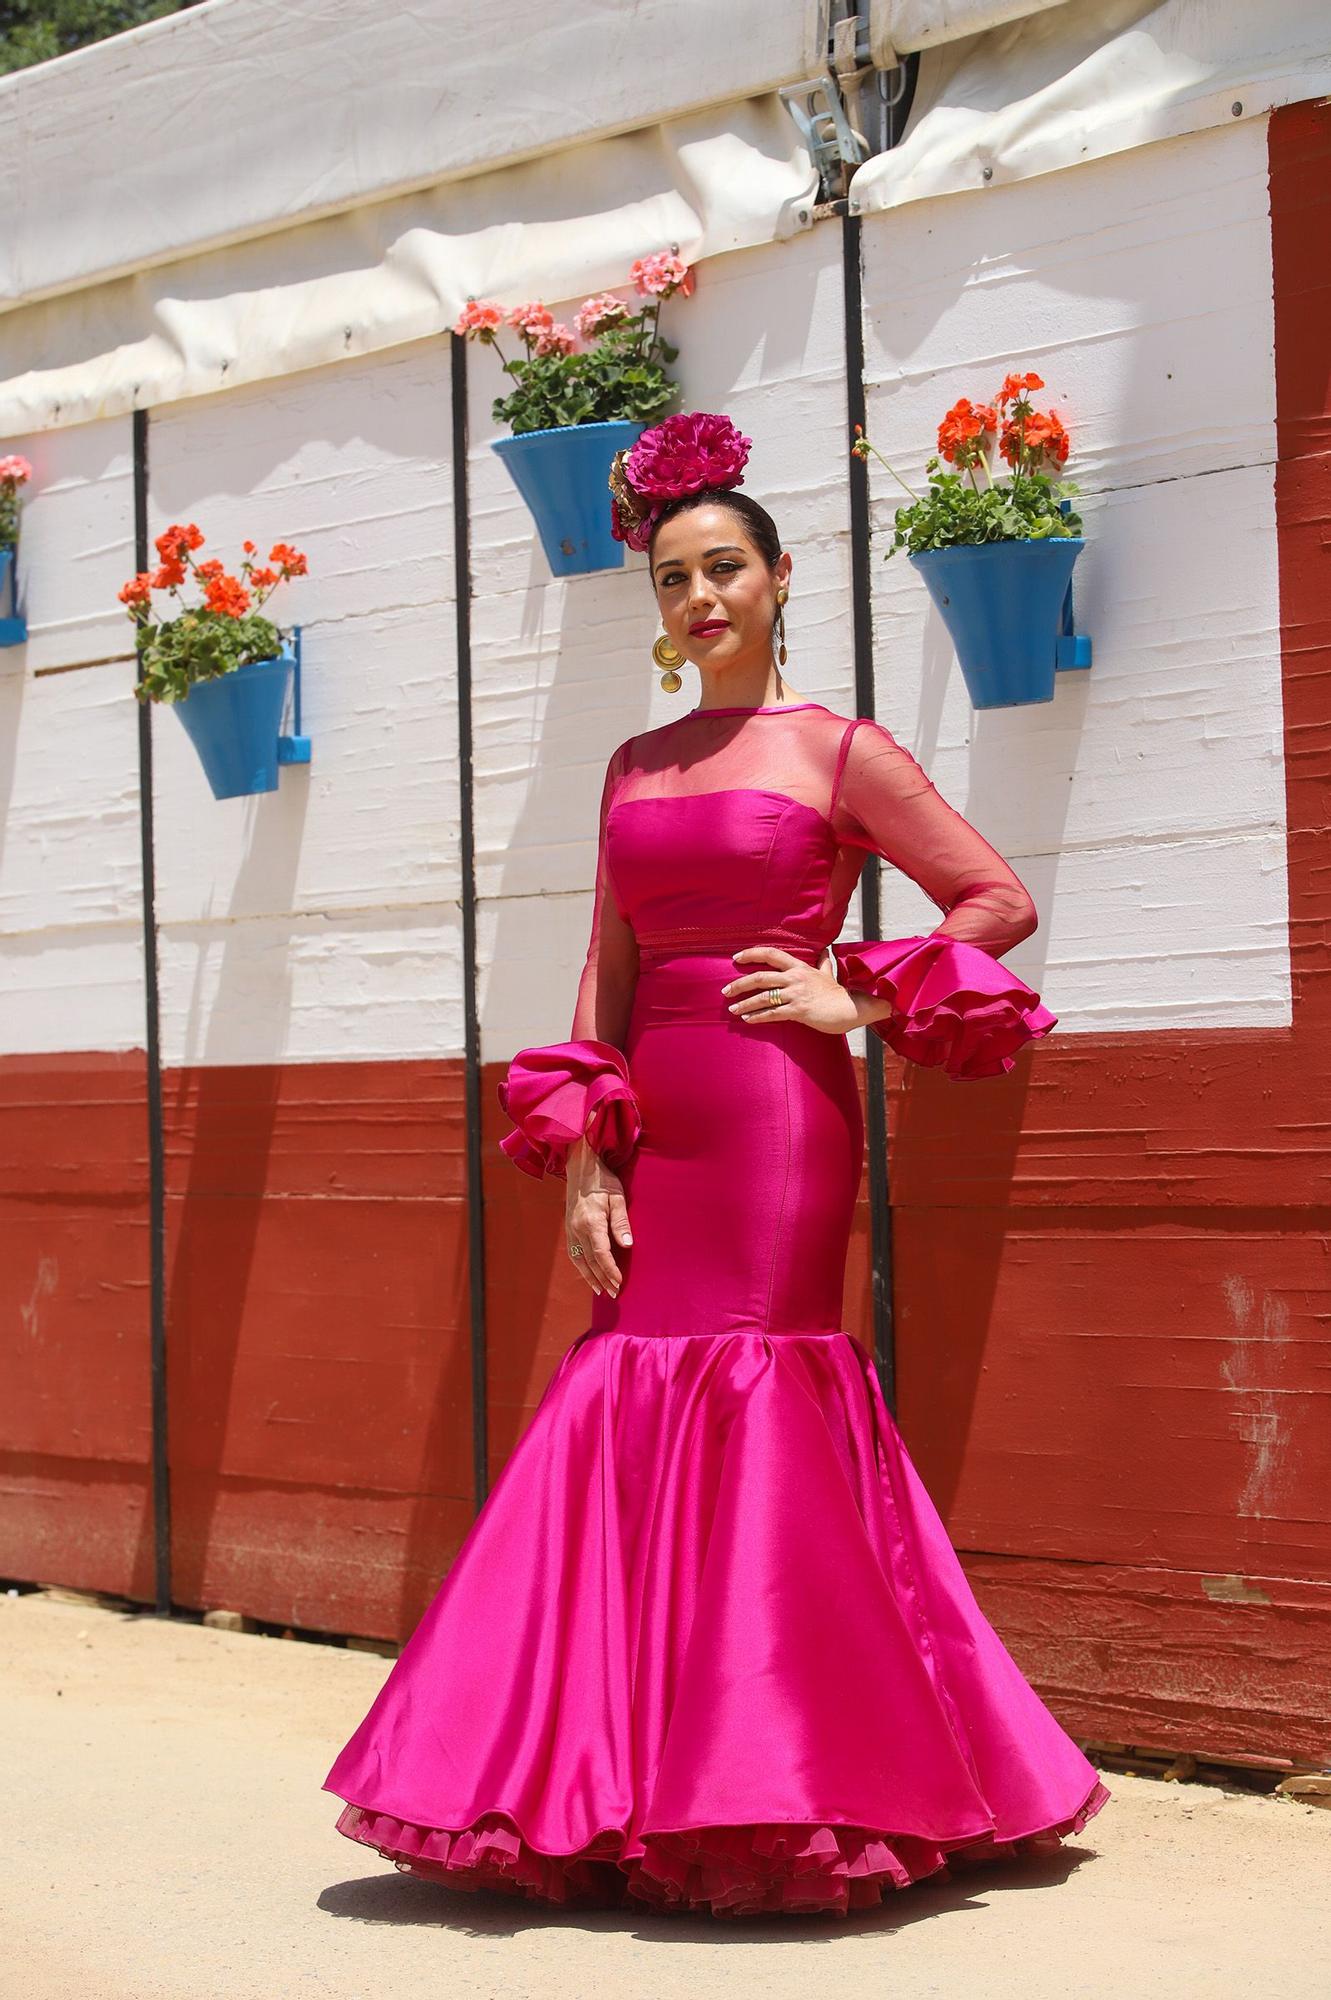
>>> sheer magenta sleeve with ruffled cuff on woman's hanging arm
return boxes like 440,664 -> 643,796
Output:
498,744 -> 642,1180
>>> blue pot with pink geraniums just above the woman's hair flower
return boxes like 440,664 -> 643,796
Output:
454,250 -> 695,576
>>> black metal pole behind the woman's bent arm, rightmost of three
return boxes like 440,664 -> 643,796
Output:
835,200 -> 897,1416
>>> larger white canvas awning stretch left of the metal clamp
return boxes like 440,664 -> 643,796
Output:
0,0 -> 821,436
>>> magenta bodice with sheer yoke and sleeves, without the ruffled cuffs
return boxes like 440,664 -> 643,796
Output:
572,702 -> 1033,1046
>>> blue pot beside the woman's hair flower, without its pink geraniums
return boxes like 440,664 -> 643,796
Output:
492,422 -> 648,576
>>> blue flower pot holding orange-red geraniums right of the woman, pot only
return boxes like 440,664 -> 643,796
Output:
909,536 -> 1091,708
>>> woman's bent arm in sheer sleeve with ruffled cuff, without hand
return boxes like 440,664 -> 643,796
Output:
831,720 -> 1057,1080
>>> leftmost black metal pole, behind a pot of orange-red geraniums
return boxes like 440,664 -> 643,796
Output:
134,410 -> 172,1618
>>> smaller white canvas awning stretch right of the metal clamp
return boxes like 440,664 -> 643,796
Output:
849,0 -> 1331,214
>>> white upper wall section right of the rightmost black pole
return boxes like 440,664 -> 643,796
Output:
863,122 -> 1291,1034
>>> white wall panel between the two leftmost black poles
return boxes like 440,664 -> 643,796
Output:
150,340 -> 462,1064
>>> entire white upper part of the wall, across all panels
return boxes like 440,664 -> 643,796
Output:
0,122 -> 1289,1064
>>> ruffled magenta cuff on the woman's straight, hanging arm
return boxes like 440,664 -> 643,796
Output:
498,1040 -> 642,1180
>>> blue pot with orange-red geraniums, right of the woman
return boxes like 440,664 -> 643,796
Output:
851,374 -> 1091,708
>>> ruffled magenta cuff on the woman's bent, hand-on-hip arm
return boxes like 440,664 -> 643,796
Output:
831,932 -> 1057,1082
